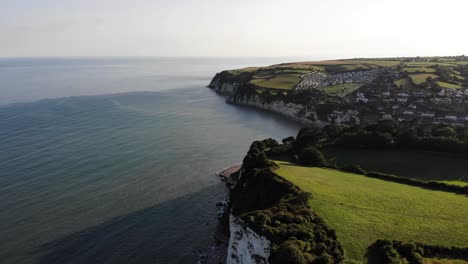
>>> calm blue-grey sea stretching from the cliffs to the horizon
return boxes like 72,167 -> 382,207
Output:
0,58 -> 299,263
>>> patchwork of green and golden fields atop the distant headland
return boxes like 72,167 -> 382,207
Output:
223,58 -> 466,94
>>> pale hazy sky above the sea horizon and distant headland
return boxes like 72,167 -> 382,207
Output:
0,0 -> 468,59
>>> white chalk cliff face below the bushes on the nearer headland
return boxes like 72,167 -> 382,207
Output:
226,214 -> 271,264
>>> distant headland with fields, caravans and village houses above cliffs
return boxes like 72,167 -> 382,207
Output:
209,56 -> 468,126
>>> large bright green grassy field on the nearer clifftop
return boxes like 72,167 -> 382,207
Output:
275,161 -> 468,260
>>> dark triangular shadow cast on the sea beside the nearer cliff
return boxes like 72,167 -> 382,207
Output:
33,185 -> 226,264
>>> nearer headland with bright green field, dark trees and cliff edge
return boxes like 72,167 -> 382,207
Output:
227,124 -> 468,264
